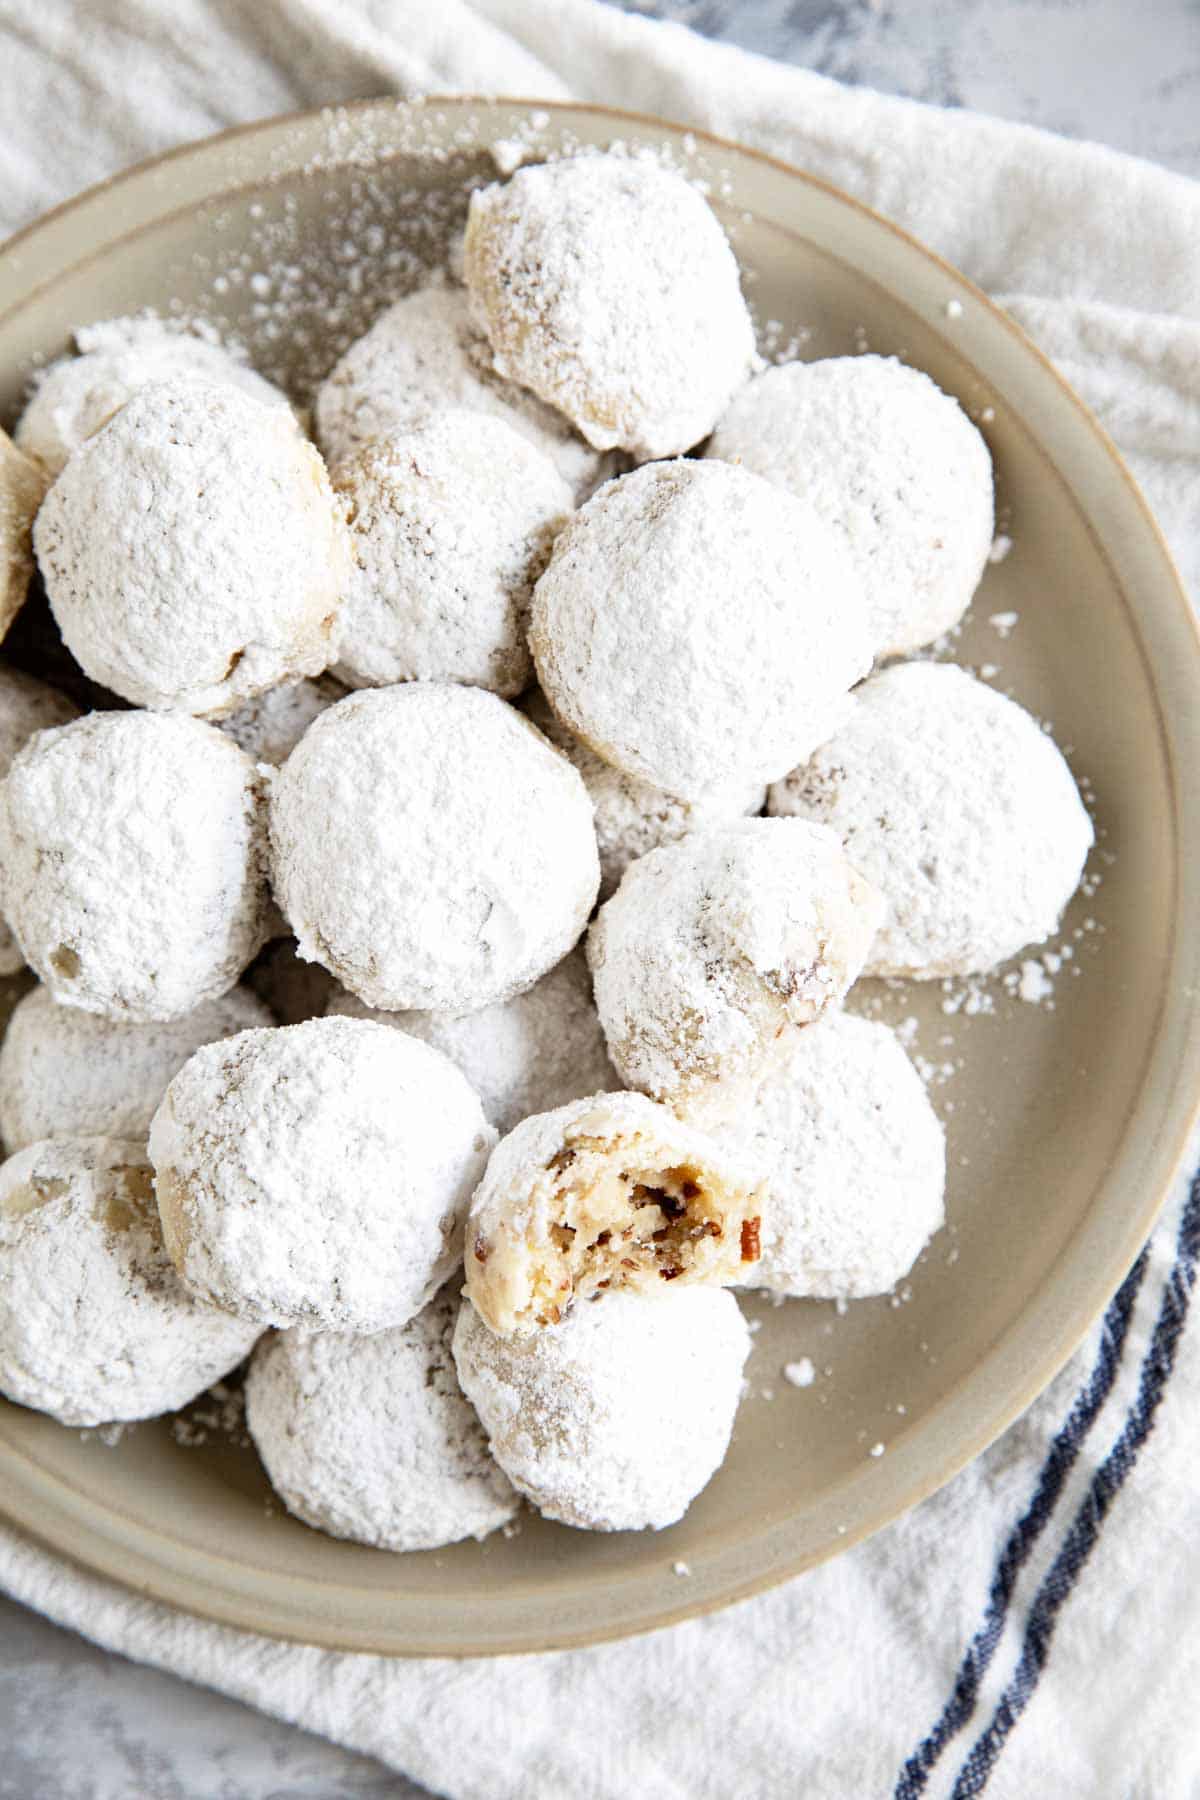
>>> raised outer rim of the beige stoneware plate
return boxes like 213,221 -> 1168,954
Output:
0,94 -> 1200,1658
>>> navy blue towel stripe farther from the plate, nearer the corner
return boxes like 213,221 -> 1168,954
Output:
952,1174 -> 1200,1800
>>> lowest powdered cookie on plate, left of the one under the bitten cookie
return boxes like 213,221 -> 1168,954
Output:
246,1289 -> 520,1550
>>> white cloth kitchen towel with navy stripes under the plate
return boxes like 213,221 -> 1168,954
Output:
0,0 -> 1200,1800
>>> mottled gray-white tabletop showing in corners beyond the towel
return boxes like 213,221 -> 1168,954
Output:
0,0 -> 1200,1800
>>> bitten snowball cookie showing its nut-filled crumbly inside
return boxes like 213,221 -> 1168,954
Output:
466,1094 -> 763,1336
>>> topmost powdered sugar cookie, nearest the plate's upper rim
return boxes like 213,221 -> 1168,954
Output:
462,155 -> 757,463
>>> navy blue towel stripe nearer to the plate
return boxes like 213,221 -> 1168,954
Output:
894,1251 -> 1148,1800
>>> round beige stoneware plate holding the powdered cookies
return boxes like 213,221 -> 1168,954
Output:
0,101 -> 1200,1654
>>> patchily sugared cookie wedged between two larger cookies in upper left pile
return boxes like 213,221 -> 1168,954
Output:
335,412 -> 572,695
